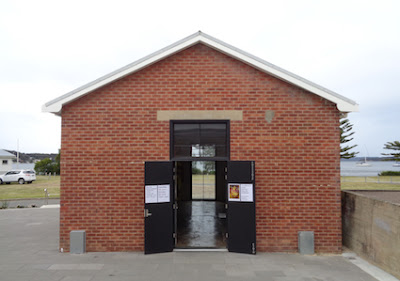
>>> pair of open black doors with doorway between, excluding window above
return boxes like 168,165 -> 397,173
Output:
144,159 -> 256,254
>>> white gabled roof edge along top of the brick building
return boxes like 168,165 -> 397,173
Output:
42,31 -> 358,115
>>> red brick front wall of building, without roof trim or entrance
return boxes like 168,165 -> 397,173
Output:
60,44 -> 341,253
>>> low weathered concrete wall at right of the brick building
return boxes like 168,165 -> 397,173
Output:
342,191 -> 400,278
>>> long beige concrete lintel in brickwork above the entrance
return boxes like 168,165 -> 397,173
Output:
157,110 -> 243,121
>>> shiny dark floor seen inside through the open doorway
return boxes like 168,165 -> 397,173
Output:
176,201 -> 226,248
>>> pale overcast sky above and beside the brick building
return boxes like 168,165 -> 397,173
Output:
0,0 -> 400,156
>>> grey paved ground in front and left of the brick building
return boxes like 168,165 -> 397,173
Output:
0,208 -> 390,281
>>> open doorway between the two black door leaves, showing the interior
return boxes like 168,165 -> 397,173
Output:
175,161 -> 227,248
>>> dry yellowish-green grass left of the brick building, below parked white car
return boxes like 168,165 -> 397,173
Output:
0,176 -> 60,200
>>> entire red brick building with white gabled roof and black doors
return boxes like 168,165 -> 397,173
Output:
43,32 -> 358,253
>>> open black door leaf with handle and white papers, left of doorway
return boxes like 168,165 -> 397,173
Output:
144,161 -> 174,254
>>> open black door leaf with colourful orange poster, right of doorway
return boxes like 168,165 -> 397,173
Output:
227,161 -> 256,254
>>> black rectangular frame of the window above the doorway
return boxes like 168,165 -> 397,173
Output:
169,120 -> 230,161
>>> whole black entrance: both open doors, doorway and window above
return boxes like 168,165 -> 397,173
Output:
145,120 -> 256,254
